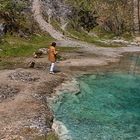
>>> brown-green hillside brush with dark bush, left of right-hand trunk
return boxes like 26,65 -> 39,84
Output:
65,0 -> 133,36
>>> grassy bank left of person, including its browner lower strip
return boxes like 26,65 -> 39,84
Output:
0,35 -> 54,69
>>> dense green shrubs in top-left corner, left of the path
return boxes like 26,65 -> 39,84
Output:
0,0 -> 34,35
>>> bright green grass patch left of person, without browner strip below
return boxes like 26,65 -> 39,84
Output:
0,35 -> 54,57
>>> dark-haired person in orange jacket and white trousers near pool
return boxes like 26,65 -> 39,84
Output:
48,42 -> 57,74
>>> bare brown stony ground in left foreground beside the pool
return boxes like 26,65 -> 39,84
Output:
0,68 -> 65,140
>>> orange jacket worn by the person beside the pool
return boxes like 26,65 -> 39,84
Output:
48,46 -> 57,63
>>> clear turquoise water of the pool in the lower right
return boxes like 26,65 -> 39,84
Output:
54,56 -> 140,140
